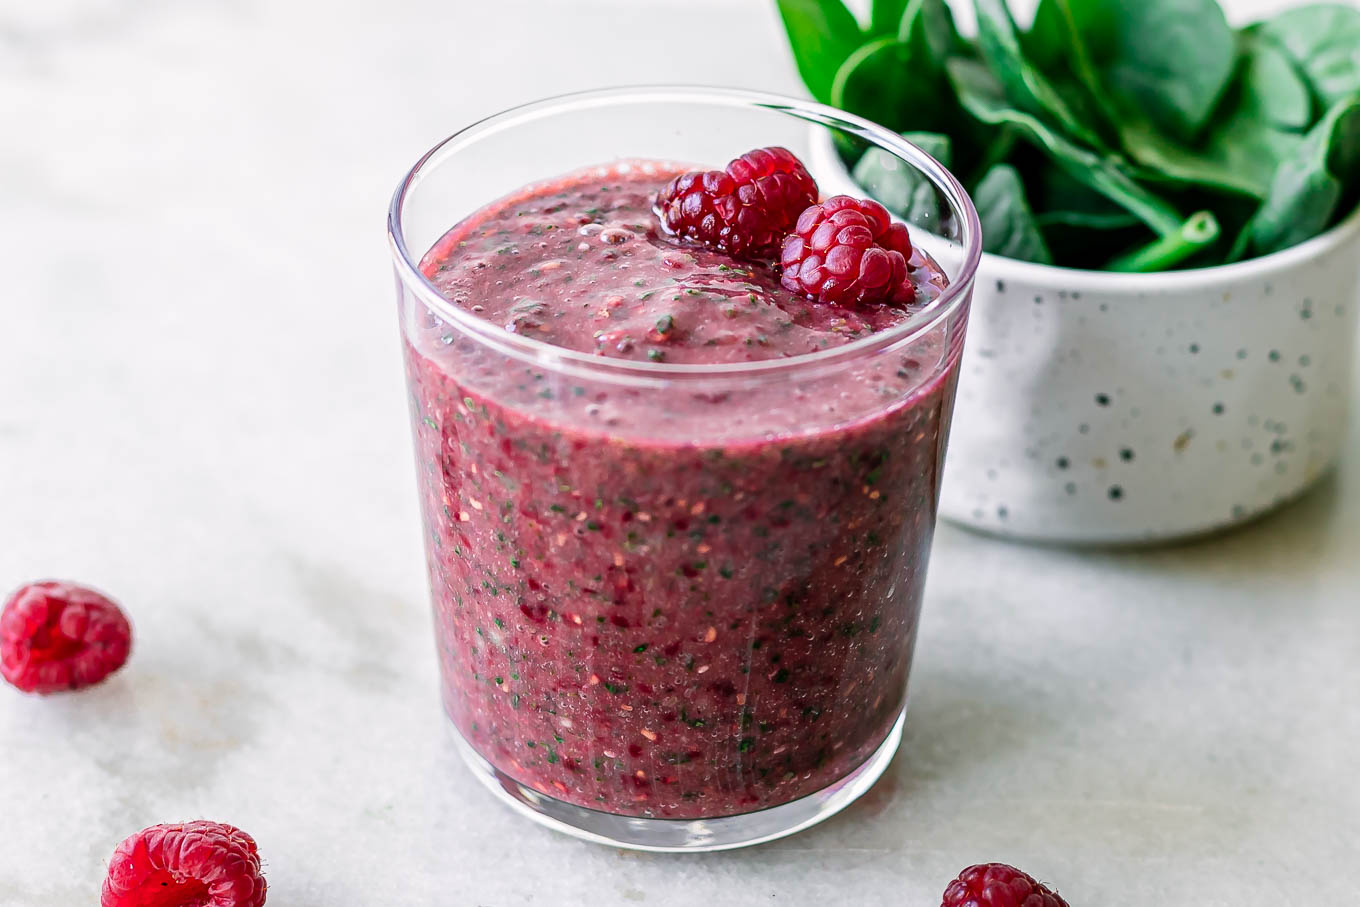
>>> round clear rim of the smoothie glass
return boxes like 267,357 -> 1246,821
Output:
388,86 -> 982,383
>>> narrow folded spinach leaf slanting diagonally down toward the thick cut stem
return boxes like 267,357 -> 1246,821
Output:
949,58 -> 1182,235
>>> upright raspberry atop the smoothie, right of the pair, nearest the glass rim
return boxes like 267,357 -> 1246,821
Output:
779,196 -> 917,306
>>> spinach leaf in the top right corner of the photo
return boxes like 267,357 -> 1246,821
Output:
1251,3 -> 1360,107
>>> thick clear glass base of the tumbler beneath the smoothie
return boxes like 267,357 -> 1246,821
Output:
449,708 -> 907,853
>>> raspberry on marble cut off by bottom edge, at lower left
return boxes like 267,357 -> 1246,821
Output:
99,821 -> 265,907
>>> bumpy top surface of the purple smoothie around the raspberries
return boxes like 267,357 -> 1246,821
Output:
420,163 -> 944,363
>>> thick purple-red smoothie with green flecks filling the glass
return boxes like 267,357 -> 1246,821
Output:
405,163 -> 959,819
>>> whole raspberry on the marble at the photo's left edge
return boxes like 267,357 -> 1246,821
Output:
0,581 -> 132,694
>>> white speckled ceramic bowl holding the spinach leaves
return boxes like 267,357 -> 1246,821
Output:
811,133 -> 1360,544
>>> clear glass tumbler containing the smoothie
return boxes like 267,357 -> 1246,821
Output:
389,88 -> 979,851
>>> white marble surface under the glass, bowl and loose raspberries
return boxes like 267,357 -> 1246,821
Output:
0,0 -> 1360,907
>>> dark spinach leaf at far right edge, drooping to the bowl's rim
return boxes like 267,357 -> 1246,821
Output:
1229,94 -> 1360,260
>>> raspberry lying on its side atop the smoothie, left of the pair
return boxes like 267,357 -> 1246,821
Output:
657,148 -> 817,257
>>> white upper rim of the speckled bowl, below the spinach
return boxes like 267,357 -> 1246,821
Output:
812,125 -> 1360,292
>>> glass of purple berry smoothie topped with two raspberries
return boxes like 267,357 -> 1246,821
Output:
390,88 -> 978,850
